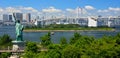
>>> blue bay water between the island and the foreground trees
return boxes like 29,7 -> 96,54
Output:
0,26 -> 120,43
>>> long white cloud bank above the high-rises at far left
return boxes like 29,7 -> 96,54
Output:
0,6 -> 39,19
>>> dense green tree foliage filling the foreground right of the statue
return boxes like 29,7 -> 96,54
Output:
0,33 -> 120,58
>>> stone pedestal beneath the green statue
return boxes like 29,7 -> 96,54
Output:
12,41 -> 25,51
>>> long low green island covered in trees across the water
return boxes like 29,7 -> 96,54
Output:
25,24 -> 114,31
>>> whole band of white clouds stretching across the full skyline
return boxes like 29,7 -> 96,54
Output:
0,5 -> 120,17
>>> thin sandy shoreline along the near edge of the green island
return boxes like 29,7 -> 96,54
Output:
24,29 -> 115,32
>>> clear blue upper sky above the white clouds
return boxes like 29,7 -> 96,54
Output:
0,0 -> 120,10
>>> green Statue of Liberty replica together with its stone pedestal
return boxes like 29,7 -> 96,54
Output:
12,13 -> 25,51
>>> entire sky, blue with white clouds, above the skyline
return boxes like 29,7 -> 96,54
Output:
0,0 -> 120,17
